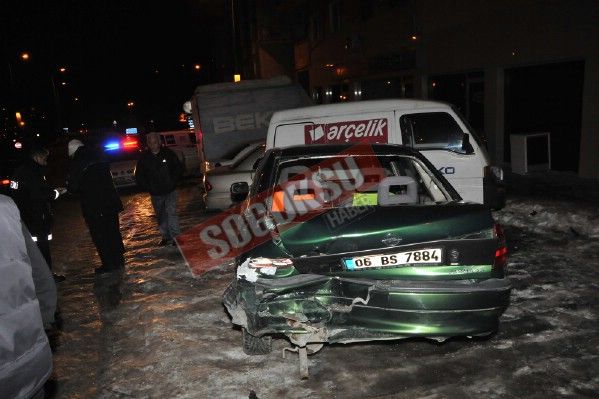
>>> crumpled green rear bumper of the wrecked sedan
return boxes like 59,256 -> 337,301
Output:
223,274 -> 511,346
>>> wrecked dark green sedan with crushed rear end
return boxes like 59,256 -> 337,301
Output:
223,144 -> 511,377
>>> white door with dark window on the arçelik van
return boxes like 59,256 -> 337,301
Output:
398,108 -> 487,203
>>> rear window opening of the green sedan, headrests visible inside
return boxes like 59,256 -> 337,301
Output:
271,155 -> 452,212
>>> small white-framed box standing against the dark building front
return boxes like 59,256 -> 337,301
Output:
510,132 -> 551,175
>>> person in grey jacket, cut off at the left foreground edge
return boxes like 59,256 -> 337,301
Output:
0,195 -> 56,399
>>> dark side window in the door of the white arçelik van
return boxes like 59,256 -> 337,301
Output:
400,112 -> 468,153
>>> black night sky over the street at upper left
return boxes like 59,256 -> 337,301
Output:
0,0 -> 230,134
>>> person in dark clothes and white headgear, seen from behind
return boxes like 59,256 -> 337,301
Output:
67,140 -> 125,274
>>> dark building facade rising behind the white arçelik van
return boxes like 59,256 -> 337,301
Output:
253,0 -> 599,178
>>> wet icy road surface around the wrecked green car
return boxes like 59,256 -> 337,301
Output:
49,177 -> 599,398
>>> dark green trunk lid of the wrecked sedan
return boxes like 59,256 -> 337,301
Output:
278,203 -> 497,278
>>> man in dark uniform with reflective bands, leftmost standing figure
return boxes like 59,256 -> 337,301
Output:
10,147 -> 66,282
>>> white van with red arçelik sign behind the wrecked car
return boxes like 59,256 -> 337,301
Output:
266,100 -> 505,209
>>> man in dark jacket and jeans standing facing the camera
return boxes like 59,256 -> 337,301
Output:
135,133 -> 183,245
